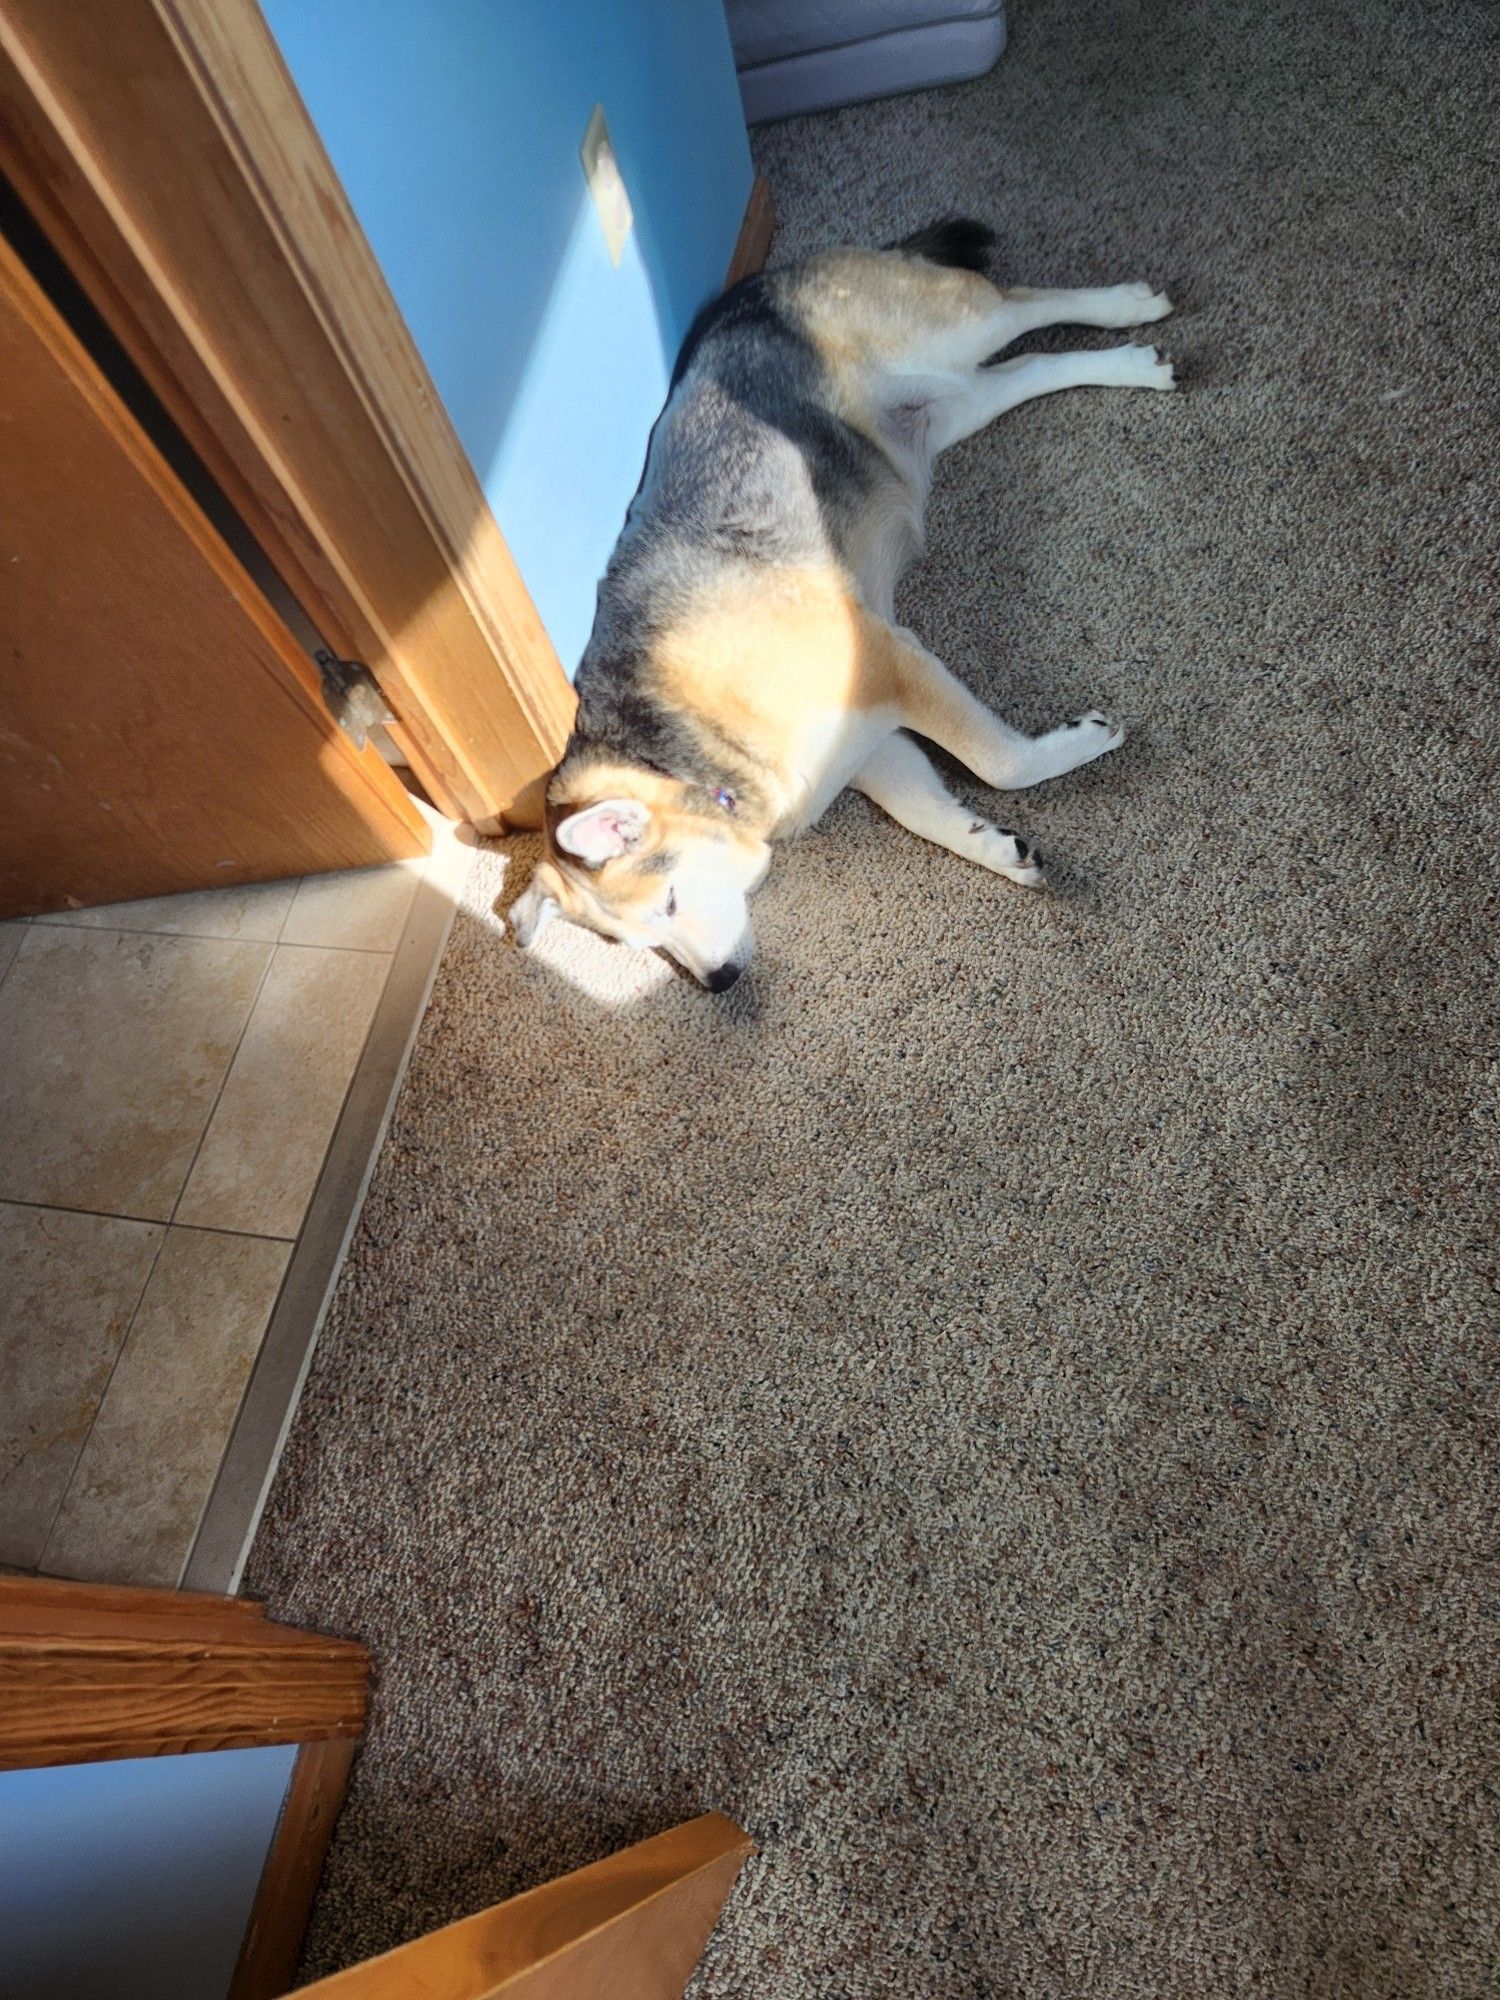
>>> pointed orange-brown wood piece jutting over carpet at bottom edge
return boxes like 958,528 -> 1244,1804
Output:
288,1812 -> 756,2000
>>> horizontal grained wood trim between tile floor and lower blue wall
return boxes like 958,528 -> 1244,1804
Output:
0,1576 -> 370,1770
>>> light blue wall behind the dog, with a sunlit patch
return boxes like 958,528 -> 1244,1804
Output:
266,0 -> 750,674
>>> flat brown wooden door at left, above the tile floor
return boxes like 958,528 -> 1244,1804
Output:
0,225 -> 430,916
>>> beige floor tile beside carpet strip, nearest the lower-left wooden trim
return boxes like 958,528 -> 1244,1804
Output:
42,1228 -> 292,1586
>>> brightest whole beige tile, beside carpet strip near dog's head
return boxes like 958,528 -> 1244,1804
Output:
176,944 -> 390,1236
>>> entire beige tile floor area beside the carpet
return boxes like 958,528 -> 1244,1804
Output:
0,828 -> 458,1584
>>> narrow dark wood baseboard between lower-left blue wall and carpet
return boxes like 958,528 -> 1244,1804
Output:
228,1740 -> 358,2000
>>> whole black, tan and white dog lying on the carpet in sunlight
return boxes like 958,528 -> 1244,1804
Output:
512,220 -> 1174,992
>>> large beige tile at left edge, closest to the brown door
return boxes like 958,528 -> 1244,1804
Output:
0,924 -> 272,1222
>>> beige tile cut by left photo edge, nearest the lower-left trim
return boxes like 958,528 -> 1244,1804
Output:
0,1202 -> 162,1568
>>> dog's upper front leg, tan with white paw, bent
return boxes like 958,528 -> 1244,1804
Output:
878,626 -> 1124,792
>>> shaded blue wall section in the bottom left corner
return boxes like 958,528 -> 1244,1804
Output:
0,1744 -> 296,2000
